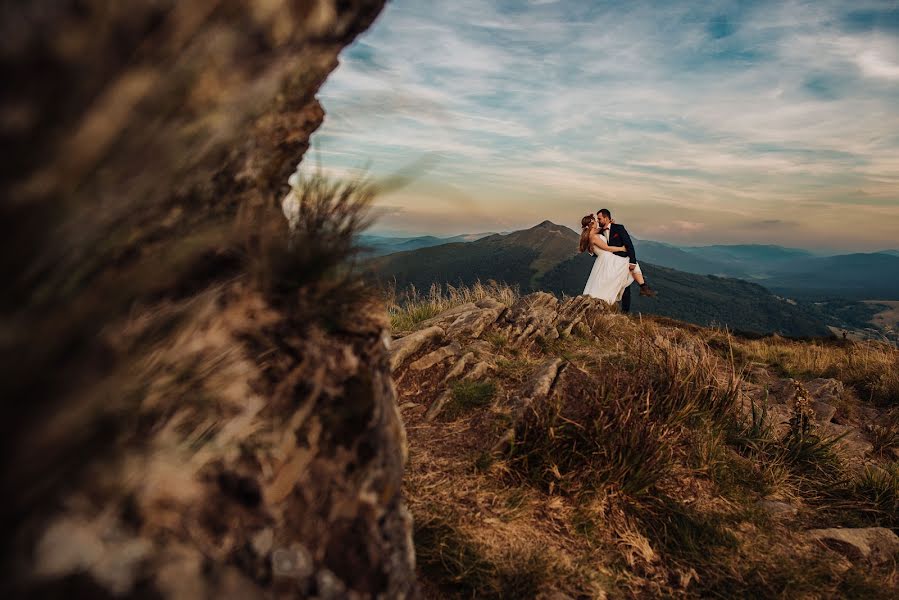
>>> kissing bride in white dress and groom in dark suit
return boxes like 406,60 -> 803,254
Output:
578,208 -> 656,313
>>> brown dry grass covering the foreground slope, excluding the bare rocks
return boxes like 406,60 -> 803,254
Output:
394,288 -> 899,598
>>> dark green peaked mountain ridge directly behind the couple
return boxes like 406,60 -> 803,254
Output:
370,221 -> 829,336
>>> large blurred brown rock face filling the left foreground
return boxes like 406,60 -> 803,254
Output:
0,0 -> 416,598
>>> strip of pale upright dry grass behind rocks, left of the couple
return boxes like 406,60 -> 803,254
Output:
387,279 -> 519,333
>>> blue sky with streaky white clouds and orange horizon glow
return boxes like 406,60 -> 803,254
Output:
304,0 -> 899,251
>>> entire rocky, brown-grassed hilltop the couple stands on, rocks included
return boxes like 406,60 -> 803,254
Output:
392,283 -> 899,598
